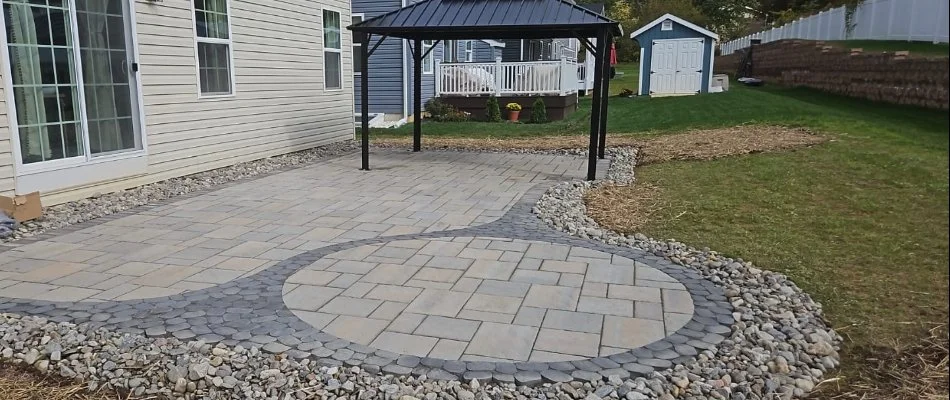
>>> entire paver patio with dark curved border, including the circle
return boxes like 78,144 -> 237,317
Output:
0,151 -> 732,380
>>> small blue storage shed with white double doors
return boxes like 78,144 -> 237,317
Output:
630,14 -> 719,96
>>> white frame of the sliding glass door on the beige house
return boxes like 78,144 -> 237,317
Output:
0,0 -> 150,180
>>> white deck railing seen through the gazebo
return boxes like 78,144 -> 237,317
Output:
435,58 -> 578,96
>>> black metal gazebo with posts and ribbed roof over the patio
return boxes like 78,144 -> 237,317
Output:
348,0 -> 621,180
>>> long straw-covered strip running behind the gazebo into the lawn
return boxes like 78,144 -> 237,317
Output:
373,125 -> 827,164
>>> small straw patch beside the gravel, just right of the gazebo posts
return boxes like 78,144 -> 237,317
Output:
584,182 -> 663,234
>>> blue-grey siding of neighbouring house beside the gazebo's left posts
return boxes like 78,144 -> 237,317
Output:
352,0 -> 403,115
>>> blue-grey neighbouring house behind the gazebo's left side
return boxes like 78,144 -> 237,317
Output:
351,0 -> 504,126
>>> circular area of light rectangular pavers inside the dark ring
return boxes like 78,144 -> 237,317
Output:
283,237 -> 694,362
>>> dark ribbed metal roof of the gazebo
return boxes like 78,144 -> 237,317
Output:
349,0 -> 621,40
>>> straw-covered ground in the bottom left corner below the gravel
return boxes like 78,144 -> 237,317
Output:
0,363 -> 131,400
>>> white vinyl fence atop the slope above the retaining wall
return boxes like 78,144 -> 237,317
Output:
719,0 -> 950,55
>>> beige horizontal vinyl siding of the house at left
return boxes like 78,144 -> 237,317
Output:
0,0 -> 358,205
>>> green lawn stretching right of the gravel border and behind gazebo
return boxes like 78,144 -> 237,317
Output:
375,65 -> 950,384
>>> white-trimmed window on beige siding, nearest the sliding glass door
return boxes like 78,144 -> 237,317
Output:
192,0 -> 234,96
